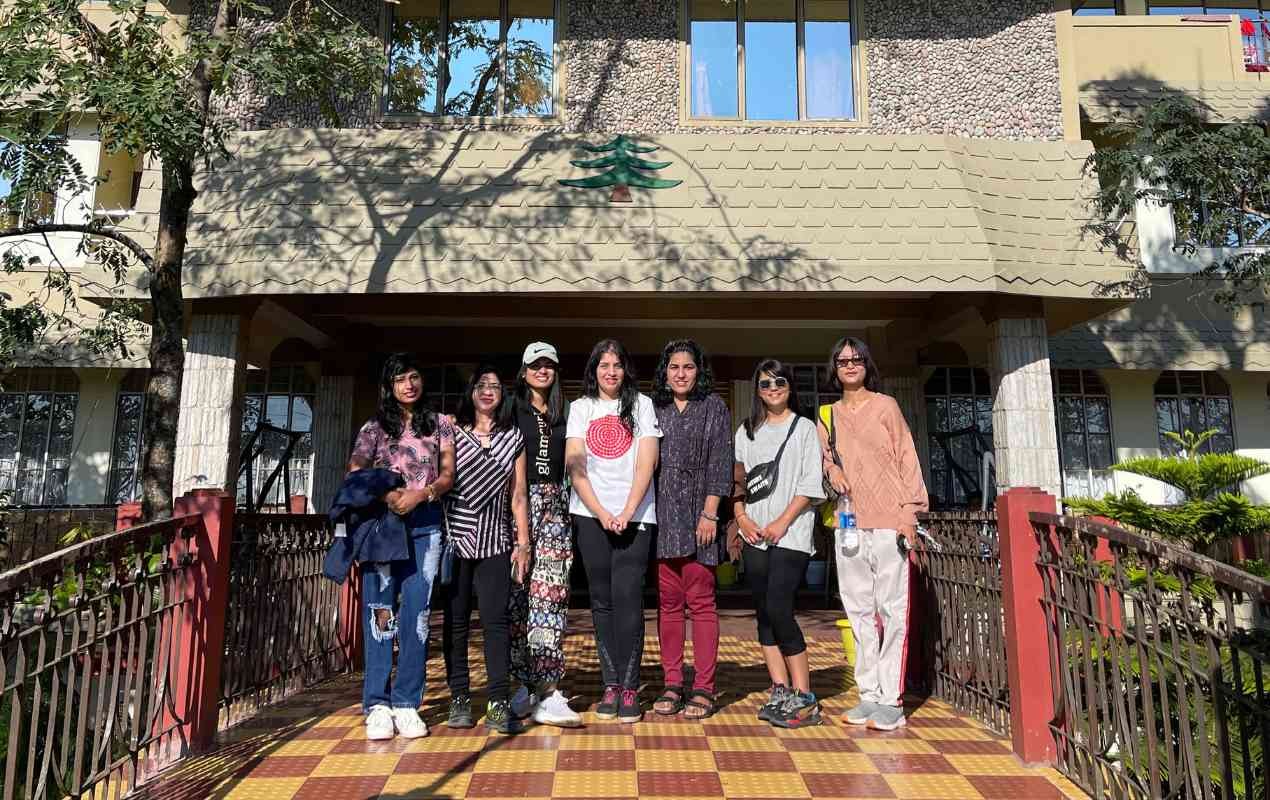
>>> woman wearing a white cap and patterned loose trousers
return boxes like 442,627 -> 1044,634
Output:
511,342 -> 582,728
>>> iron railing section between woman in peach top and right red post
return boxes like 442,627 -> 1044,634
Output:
913,510 -> 1010,734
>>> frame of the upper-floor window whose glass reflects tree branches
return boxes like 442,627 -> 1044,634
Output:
380,0 -> 568,120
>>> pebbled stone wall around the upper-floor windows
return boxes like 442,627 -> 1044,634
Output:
215,0 -> 1062,140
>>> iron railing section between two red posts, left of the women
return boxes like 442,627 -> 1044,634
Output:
221,513 -> 347,726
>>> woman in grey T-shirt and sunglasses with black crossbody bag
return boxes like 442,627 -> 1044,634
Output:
733,358 -> 824,728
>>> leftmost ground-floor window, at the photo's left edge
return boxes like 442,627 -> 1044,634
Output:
0,370 -> 79,505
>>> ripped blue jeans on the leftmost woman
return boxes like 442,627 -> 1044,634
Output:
361,524 -> 441,711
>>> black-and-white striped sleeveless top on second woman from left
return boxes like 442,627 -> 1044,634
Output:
445,425 -> 525,559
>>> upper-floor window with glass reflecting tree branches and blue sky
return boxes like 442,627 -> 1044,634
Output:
385,0 -> 559,117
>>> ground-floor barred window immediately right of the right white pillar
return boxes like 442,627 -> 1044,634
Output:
1054,370 -> 1115,498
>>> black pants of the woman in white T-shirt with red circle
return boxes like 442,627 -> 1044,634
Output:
573,514 -> 657,690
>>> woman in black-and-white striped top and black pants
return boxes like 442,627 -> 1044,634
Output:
443,366 -> 530,733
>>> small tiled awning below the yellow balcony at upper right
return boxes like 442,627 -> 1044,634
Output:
1081,77 -> 1270,122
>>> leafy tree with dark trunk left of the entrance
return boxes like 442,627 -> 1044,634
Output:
0,0 -> 385,517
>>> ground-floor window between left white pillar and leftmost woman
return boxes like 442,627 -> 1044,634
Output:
237,362 -> 318,507
